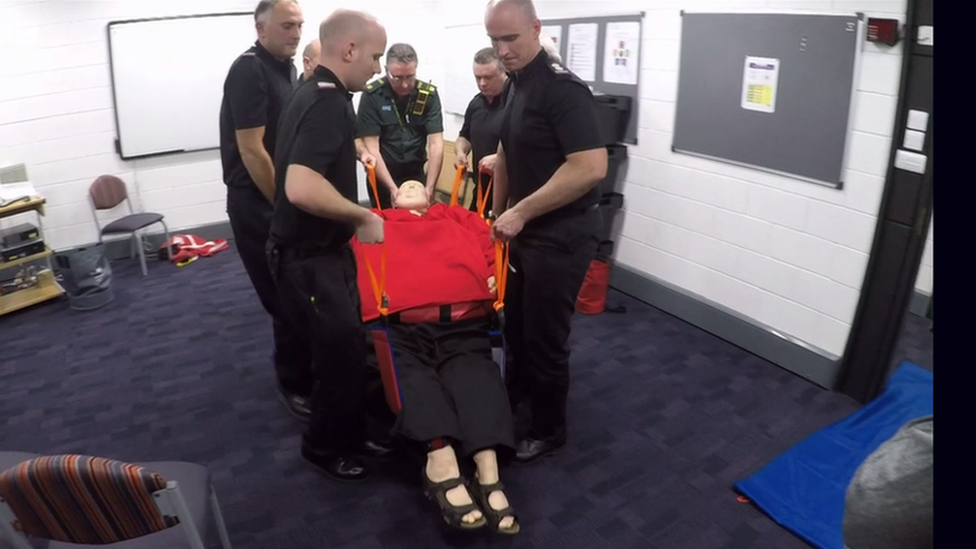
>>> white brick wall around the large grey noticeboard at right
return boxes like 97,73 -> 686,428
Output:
442,0 -> 908,355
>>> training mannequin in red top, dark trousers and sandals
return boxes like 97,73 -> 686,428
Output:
354,181 -> 519,534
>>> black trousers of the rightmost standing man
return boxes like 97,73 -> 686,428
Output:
505,208 -> 603,440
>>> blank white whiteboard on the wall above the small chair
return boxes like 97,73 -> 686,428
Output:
108,13 -> 257,159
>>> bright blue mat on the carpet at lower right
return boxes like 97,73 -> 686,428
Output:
734,362 -> 933,549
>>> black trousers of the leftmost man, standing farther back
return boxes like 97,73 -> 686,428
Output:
227,186 -> 313,397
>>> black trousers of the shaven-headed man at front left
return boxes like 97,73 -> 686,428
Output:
268,242 -> 368,452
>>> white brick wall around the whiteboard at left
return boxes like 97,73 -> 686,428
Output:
0,0 -> 444,249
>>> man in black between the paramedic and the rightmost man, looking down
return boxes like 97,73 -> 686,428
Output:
454,47 -> 506,216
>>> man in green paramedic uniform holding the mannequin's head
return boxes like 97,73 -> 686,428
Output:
356,44 -> 444,209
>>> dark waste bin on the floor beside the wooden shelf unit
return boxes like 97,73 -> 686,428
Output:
54,242 -> 115,311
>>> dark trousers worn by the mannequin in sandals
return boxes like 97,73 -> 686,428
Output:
389,320 -> 515,456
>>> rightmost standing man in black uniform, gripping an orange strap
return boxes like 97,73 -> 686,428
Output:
485,0 -> 607,463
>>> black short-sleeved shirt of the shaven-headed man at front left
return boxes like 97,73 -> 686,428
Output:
271,65 -> 359,250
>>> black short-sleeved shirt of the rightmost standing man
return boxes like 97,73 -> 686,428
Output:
501,50 -> 605,224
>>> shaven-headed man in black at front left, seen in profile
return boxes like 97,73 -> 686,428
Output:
268,10 -> 389,481
